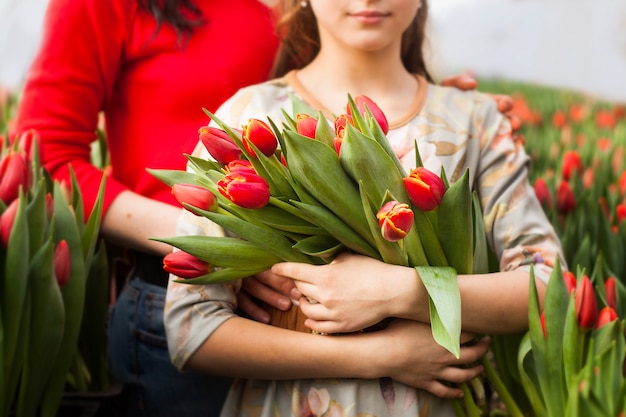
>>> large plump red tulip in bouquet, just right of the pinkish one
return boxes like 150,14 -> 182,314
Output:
217,171 -> 270,209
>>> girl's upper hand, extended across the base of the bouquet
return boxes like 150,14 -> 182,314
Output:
272,254 -> 428,334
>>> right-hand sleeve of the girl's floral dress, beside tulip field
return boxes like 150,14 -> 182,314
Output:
472,96 -> 566,282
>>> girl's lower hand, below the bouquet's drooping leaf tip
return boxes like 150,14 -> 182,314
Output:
358,319 -> 490,398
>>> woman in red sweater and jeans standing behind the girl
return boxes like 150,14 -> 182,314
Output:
16,0 -> 280,417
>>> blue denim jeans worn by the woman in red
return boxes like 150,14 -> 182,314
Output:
108,278 -> 231,417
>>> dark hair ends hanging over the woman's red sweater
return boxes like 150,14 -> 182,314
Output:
137,0 -> 204,35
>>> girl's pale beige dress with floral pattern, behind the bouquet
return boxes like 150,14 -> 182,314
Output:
165,72 -> 564,417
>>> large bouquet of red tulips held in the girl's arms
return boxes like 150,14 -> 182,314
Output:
152,96 -> 516,415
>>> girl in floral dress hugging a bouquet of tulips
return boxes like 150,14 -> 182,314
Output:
165,0 -> 562,416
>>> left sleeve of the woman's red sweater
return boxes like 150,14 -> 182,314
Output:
15,0 -> 137,214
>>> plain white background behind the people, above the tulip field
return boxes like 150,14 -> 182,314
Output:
0,0 -> 626,102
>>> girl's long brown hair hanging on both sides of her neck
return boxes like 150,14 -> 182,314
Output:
272,0 -> 433,82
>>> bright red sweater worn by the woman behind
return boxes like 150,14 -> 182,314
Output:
15,0 -> 278,216
